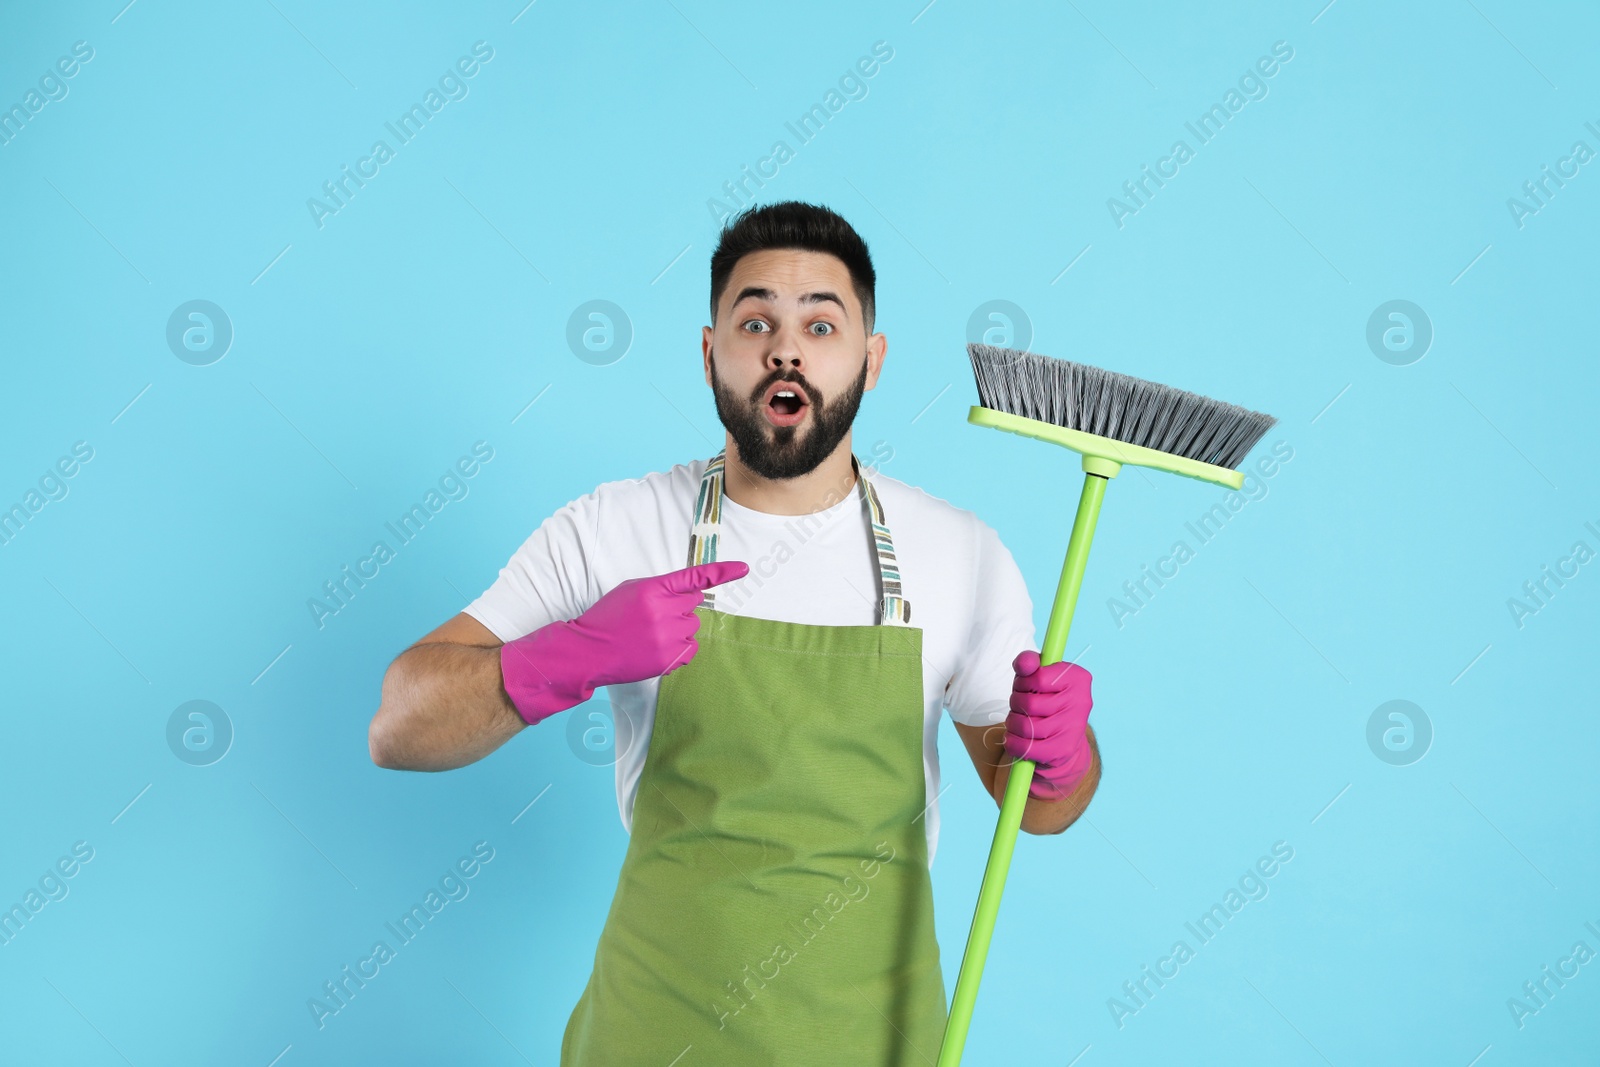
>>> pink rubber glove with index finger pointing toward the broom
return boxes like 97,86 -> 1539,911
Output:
501,560 -> 750,725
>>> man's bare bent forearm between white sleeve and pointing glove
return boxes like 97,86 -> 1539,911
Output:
368,641 -> 528,771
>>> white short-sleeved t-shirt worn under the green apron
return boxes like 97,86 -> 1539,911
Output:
466,459 -> 1038,865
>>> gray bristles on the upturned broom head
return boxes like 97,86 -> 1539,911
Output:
966,344 -> 1277,470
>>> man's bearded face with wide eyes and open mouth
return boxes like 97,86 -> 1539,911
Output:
701,248 -> 888,480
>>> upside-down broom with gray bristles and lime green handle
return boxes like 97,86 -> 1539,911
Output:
938,344 -> 1277,1067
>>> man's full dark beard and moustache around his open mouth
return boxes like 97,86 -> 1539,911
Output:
710,352 -> 867,480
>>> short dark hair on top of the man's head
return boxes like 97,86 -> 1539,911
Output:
710,200 -> 877,333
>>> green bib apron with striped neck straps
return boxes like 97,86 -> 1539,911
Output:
560,453 -> 947,1067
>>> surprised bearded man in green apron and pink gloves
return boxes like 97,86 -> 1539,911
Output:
370,202 -> 1099,1067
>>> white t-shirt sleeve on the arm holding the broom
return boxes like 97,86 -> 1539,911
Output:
944,515 -> 1038,726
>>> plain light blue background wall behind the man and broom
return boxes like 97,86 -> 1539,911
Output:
0,0 -> 1600,1067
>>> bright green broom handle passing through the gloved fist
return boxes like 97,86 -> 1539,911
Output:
938,470 -> 1117,1067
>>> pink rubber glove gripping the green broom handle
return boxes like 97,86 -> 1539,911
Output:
1005,649 -> 1094,800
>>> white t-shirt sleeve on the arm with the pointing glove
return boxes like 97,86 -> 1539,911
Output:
462,493 -> 600,641
